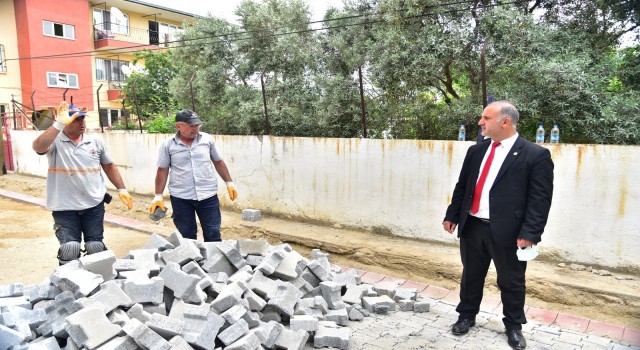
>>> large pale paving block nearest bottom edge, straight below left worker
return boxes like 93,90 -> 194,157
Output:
65,302 -> 122,349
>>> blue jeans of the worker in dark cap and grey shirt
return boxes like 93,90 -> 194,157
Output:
169,195 -> 222,242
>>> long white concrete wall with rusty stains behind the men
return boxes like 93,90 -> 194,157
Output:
12,131 -> 640,272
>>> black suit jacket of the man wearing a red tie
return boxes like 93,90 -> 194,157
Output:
445,136 -> 553,246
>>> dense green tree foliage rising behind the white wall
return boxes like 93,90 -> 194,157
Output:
142,0 -> 640,144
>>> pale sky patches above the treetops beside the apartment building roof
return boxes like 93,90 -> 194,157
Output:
145,0 -> 342,23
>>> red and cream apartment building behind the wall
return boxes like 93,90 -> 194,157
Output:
0,0 -> 197,130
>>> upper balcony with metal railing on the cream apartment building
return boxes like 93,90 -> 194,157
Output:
93,23 -> 176,50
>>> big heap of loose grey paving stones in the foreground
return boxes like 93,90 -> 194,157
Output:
0,232 -> 429,350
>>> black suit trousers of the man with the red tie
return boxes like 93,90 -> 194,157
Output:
456,215 -> 527,329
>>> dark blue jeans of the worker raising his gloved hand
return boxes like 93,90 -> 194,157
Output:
51,202 -> 104,244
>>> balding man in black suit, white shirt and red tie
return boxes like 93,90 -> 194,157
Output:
442,101 -> 553,349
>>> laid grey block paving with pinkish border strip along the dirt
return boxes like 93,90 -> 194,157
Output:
0,189 -> 640,350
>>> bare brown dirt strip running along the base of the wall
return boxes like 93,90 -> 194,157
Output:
0,174 -> 640,329
